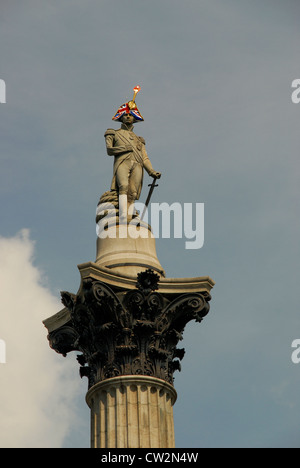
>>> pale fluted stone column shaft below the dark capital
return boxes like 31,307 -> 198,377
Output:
86,376 -> 177,448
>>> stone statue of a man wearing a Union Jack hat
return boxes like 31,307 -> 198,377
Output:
105,87 -> 161,220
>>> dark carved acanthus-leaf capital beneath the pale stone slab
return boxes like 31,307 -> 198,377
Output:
51,270 -> 210,386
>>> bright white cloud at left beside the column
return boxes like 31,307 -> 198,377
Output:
0,230 -> 82,448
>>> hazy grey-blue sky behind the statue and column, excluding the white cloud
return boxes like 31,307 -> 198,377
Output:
0,0 -> 300,447
